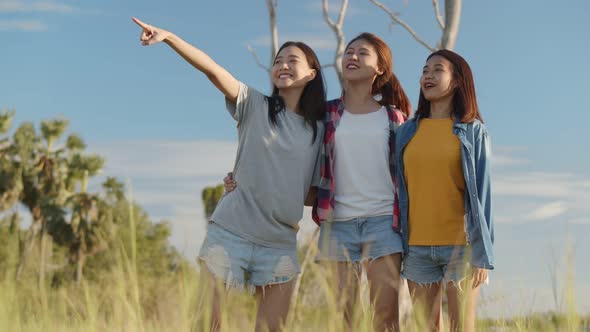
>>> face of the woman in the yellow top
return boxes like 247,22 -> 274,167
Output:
420,55 -> 455,102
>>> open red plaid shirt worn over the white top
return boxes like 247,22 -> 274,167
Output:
312,98 -> 406,232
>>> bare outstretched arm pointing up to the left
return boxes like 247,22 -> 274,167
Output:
133,17 -> 240,103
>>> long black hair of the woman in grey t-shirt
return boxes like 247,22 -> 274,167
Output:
268,41 -> 327,142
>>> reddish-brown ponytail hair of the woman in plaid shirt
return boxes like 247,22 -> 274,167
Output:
346,32 -> 412,117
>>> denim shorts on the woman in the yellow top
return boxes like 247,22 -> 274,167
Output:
402,245 -> 471,284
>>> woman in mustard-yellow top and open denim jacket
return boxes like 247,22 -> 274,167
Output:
395,50 -> 494,331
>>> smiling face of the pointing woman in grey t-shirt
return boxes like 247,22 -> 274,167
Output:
271,46 -> 316,90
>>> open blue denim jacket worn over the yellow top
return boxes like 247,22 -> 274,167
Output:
395,116 -> 494,270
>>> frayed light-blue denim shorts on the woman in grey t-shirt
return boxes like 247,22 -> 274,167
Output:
199,222 -> 300,289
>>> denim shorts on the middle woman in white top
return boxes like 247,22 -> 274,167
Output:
316,215 -> 403,263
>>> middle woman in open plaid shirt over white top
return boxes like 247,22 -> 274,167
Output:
313,33 -> 411,331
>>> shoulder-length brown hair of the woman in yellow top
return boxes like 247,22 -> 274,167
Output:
416,50 -> 483,123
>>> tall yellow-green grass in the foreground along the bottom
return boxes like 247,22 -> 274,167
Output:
0,240 -> 590,332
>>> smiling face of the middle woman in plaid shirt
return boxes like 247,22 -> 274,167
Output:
342,39 -> 383,81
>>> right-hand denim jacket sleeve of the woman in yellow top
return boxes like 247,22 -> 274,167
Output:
472,123 -> 494,269
